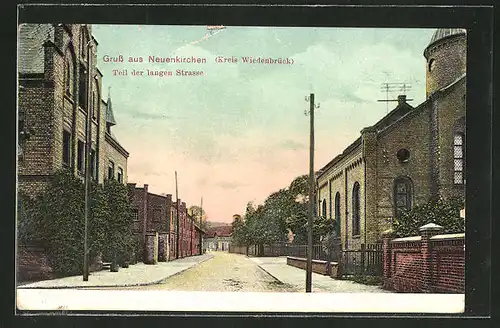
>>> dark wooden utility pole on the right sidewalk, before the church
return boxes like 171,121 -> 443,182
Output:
304,93 -> 319,293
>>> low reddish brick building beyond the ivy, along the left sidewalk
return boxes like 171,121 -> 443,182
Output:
128,183 -> 202,261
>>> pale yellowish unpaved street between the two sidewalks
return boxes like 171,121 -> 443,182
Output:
126,252 -> 297,292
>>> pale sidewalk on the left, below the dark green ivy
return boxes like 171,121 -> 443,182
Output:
17,254 -> 213,289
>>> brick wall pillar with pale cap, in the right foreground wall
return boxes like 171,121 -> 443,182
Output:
418,223 -> 443,293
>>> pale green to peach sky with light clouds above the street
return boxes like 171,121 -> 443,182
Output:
92,25 -> 434,223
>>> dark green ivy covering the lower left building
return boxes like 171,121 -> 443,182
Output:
17,170 -> 137,275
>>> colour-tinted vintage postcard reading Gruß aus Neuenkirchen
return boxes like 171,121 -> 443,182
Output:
16,22 -> 467,313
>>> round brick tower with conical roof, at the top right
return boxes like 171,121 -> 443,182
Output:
424,28 -> 467,97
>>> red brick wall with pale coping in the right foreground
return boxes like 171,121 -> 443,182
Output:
383,225 -> 465,293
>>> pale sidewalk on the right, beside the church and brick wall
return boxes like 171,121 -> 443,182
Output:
249,257 -> 390,293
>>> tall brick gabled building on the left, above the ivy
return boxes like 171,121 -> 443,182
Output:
18,24 -> 129,195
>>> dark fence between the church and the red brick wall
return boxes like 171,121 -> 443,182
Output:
342,243 -> 384,276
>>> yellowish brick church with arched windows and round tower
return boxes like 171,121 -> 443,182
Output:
316,29 -> 466,249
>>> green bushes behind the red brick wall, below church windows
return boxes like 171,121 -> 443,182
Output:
393,198 -> 465,237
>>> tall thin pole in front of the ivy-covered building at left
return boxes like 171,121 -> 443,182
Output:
83,40 -> 94,281
